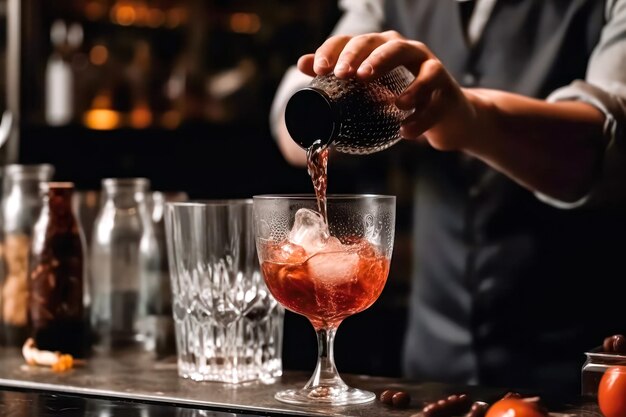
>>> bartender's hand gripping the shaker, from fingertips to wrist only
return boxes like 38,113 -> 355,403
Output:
298,31 -> 476,150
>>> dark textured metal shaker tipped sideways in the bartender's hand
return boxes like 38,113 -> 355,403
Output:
285,66 -> 415,154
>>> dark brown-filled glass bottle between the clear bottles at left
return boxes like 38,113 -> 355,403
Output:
28,182 -> 86,357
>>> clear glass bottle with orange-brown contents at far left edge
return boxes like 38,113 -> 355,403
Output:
0,164 -> 54,346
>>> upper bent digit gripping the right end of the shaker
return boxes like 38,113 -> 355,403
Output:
396,59 -> 454,111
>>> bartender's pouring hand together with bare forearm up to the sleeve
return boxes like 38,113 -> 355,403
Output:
298,31 -> 605,202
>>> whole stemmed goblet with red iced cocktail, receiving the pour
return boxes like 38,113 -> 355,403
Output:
253,195 -> 396,405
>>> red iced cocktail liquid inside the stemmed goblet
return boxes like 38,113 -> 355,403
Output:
261,240 -> 389,330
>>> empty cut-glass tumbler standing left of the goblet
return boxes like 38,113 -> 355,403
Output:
165,200 -> 284,383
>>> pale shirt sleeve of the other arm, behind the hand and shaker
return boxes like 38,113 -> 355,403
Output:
269,0 -> 384,141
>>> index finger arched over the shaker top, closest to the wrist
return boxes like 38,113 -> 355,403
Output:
357,39 -> 434,80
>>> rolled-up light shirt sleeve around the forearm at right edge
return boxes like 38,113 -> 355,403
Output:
536,0 -> 626,209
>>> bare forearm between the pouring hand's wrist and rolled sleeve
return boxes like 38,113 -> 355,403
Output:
454,89 -> 604,202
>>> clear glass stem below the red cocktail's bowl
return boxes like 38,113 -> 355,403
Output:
304,328 -> 348,397
